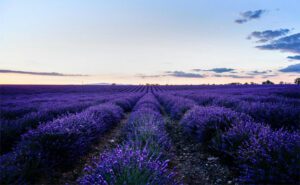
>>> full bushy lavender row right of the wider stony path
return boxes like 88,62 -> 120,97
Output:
157,93 -> 300,183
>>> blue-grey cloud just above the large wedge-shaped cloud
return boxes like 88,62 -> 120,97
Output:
247,29 -> 290,42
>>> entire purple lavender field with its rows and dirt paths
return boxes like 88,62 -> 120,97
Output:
0,85 -> 300,185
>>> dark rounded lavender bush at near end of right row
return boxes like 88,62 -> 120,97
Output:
237,129 -> 300,184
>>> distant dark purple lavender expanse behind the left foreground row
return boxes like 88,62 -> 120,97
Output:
0,86 -> 163,154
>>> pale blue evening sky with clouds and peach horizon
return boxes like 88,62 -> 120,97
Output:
0,0 -> 300,84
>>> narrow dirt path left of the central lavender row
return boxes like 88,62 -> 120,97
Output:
39,113 -> 129,185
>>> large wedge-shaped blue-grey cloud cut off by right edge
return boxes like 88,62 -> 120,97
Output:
256,33 -> 300,53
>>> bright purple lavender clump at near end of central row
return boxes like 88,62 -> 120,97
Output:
78,145 -> 178,185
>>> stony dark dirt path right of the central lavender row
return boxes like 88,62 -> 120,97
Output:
165,116 -> 236,185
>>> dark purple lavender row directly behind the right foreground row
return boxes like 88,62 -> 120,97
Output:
175,90 -> 300,130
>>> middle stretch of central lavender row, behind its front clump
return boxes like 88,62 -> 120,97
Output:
125,93 -> 170,155
